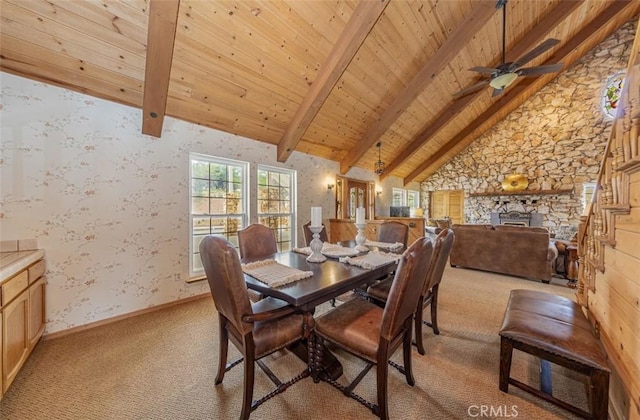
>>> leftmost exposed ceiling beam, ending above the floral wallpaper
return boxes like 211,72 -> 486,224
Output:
142,0 -> 180,137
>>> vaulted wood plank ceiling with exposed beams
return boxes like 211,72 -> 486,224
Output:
0,0 -> 640,183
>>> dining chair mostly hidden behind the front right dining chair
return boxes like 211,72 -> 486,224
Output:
367,229 -> 455,354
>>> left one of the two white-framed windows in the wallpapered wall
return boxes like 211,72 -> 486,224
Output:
189,153 -> 249,277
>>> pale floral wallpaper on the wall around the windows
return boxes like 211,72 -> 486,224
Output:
0,73 -> 390,333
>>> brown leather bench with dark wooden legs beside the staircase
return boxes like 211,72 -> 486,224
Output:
500,290 -> 610,419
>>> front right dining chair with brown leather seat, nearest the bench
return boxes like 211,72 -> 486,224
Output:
311,238 -> 433,419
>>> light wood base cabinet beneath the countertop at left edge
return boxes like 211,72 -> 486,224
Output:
0,260 -> 46,395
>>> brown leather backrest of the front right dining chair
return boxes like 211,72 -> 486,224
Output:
380,237 -> 433,341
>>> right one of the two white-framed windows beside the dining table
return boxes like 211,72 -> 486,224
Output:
258,165 -> 296,251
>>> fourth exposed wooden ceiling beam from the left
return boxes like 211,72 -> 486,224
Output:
380,0 -> 584,180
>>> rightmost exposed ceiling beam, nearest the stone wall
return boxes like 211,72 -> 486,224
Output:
404,0 -> 639,185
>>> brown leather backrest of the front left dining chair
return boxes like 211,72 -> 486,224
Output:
200,235 -> 252,334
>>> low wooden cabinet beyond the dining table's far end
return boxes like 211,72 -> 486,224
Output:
329,217 -> 425,245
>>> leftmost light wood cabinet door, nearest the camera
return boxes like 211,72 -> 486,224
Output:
2,291 -> 29,392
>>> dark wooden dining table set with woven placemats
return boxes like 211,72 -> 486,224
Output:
242,244 -> 397,380
